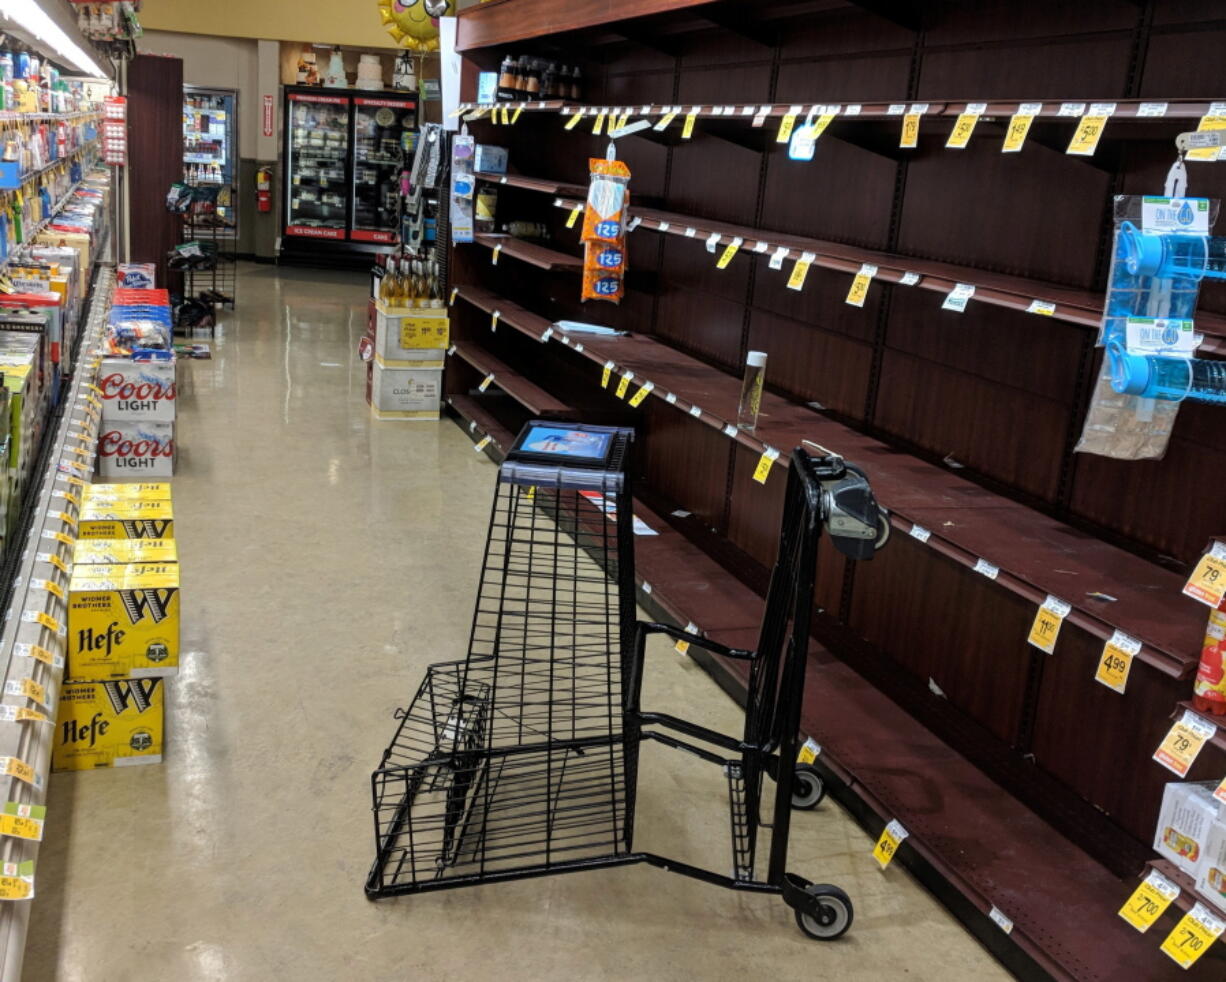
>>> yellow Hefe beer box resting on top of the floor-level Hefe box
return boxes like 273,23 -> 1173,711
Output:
64,563 -> 179,682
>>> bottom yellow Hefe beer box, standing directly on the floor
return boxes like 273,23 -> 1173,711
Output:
51,678 -> 166,771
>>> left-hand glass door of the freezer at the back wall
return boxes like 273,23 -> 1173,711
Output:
283,89 -> 352,242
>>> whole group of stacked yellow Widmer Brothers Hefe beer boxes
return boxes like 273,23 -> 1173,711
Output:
51,482 -> 180,771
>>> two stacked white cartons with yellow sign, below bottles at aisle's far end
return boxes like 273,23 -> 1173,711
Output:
367,299 -> 450,419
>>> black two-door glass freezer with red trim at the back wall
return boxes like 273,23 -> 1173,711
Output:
282,86 -> 417,254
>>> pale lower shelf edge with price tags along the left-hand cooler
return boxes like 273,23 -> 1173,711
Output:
0,266 -> 114,980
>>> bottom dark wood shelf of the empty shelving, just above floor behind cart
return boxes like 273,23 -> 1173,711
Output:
441,396 -> 1216,980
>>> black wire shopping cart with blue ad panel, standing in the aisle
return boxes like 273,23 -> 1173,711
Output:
365,421 -> 889,939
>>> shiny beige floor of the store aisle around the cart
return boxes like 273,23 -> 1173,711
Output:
25,266 -> 1007,982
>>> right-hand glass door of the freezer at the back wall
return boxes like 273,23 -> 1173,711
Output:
349,96 -> 417,244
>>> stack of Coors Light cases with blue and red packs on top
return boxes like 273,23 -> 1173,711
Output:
98,281 -> 178,481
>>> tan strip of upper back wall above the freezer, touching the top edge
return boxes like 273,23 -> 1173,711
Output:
141,0 -> 404,48
